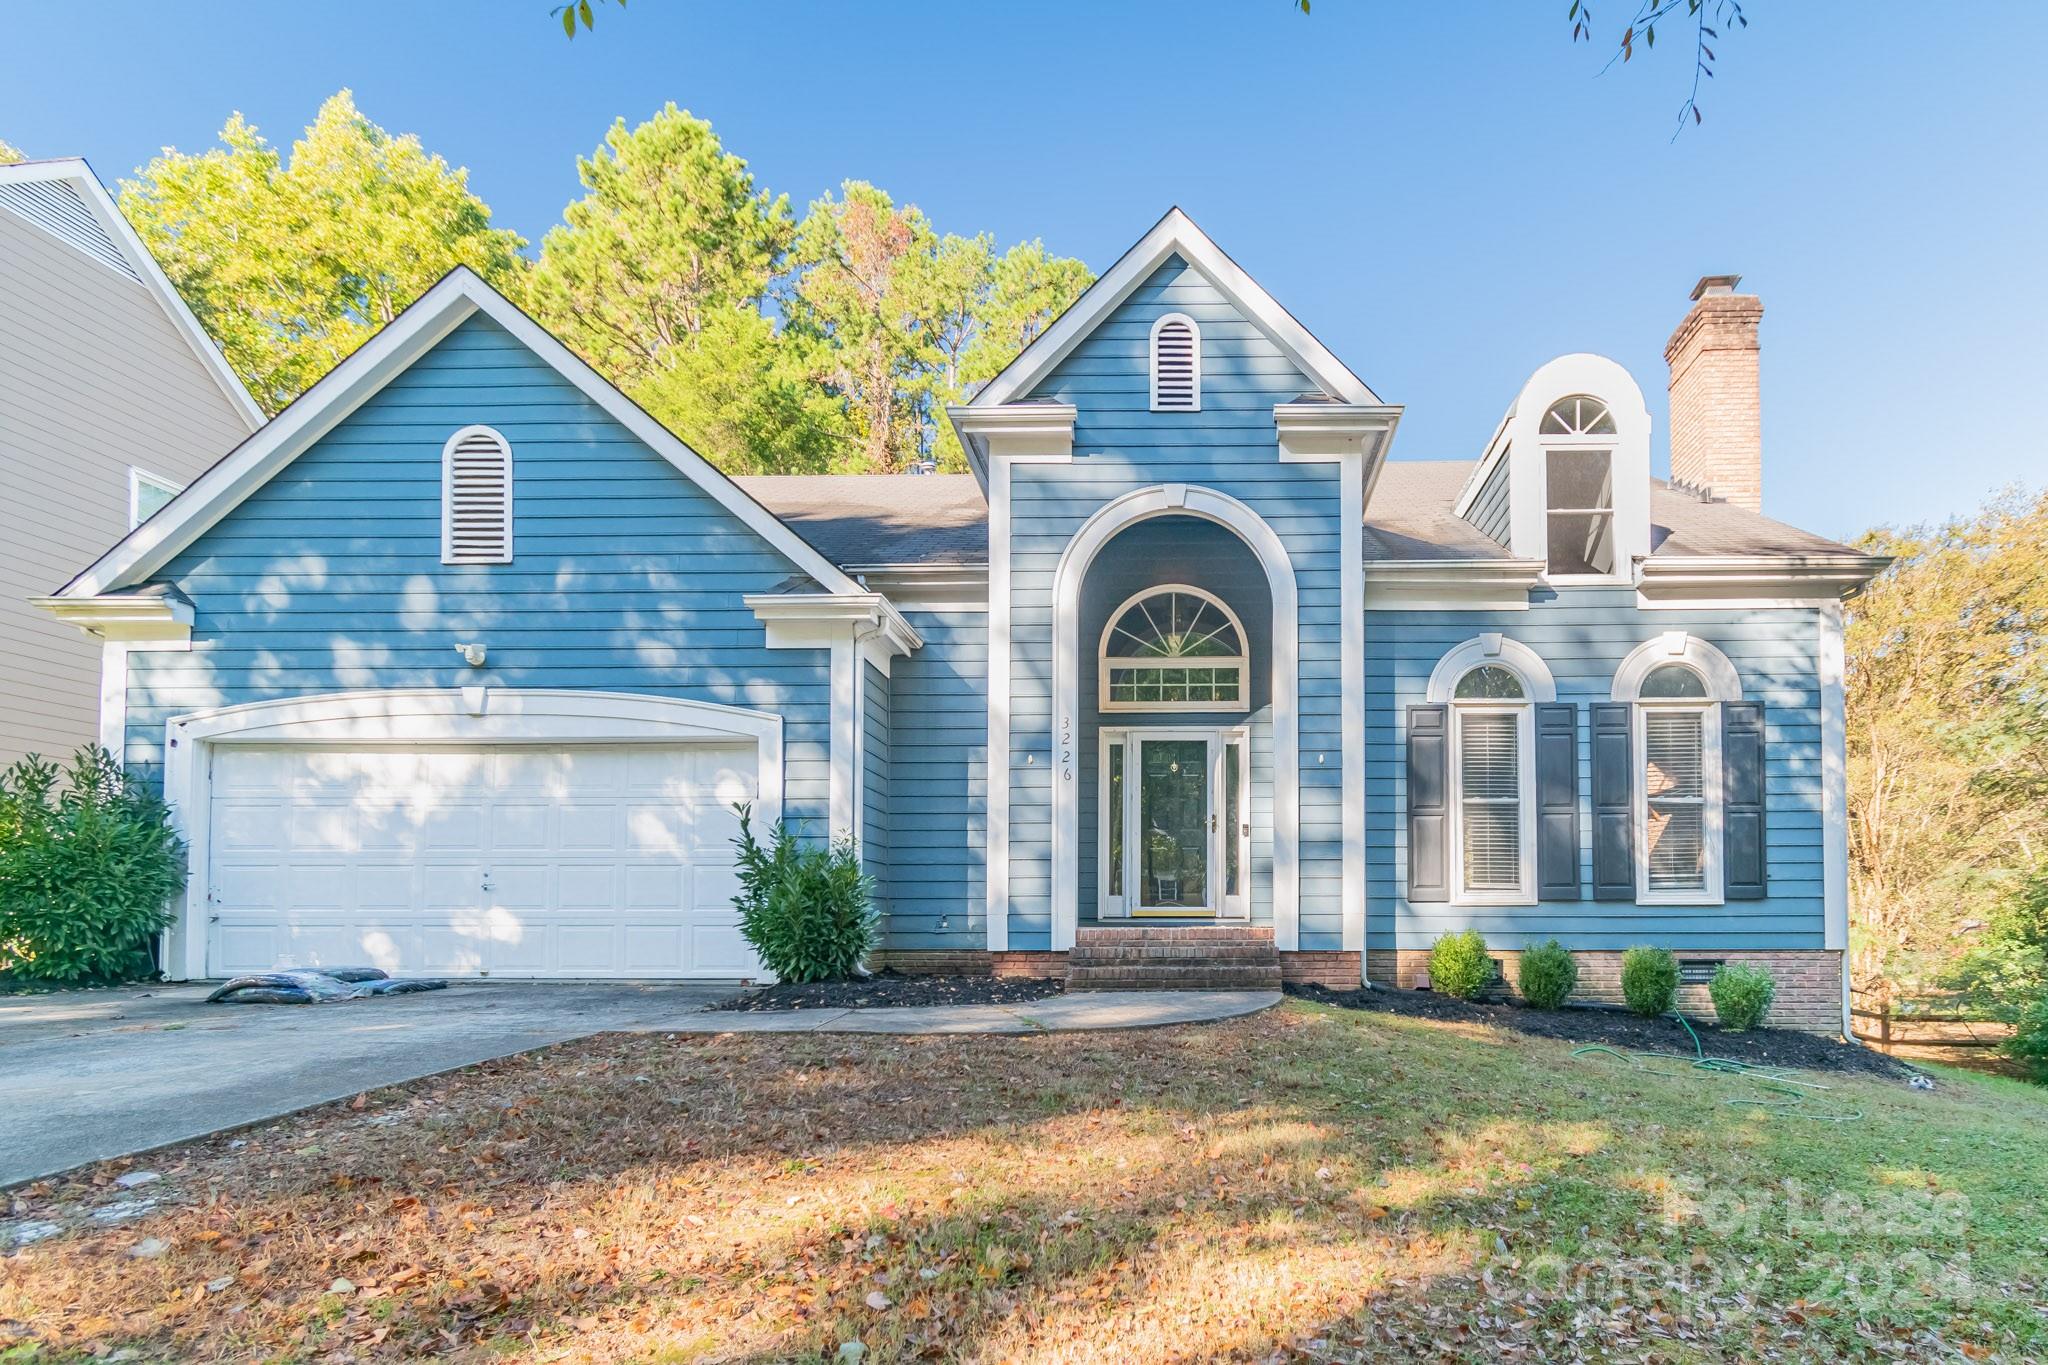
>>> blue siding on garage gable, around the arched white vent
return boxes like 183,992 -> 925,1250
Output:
127,317 -> 831,829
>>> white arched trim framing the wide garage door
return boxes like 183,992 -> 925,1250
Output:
164,688 -> 782,980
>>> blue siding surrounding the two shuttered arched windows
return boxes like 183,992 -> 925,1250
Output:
1366,587 -> 1825,950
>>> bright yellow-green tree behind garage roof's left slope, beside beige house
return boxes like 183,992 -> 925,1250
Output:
121,90 -> 524,413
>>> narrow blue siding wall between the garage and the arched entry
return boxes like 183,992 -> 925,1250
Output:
883,612 -> 989,950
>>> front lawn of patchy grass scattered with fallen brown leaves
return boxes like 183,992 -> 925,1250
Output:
0,1001 -> 2048,1363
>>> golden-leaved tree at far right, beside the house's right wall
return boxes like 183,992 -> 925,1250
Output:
1847,493 -> 2048,1002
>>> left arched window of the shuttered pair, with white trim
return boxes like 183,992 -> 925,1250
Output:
1427,634 -> 1556,905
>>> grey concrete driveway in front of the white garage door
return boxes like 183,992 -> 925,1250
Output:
0,982 -> 733,1187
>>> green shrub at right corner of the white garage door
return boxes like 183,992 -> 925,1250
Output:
733,806 -> 879,980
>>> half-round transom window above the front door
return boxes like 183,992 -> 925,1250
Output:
1100,583 -> 1251,710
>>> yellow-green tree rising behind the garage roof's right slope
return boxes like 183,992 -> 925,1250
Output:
528,104 -> 848,473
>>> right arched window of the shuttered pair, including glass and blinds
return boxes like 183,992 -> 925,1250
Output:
1614,632 -> 1763,905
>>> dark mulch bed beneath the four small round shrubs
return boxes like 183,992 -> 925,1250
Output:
1286,984 -> 1913,1081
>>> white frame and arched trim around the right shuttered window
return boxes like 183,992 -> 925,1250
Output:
1612,630 -> 1743,907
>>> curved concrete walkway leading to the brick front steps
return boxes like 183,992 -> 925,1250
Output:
671,990 -> 1280,1036
